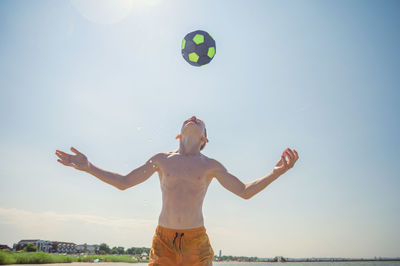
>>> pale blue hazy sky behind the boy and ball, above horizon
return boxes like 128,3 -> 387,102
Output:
0,0 -> 400,257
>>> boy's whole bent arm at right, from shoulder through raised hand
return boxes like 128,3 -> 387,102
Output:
214,149 -> 299,199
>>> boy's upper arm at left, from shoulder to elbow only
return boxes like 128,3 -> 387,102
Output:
122,153 -> 164,190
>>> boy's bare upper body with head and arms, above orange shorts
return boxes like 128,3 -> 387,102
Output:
56,116 -> 299,229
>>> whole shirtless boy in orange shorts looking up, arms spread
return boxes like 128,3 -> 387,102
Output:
56,116 -> 299,266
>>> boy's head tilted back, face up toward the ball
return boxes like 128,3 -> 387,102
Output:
176,116 -> 208,150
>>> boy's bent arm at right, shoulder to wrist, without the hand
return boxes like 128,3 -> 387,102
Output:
214,160 -> 279,199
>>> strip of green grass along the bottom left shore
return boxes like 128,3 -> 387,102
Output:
0,250 -> 148,265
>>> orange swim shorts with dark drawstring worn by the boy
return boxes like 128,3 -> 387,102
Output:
149,225 -> 214,266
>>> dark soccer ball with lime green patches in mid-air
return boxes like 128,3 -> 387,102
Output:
181,30 -> 215,66
